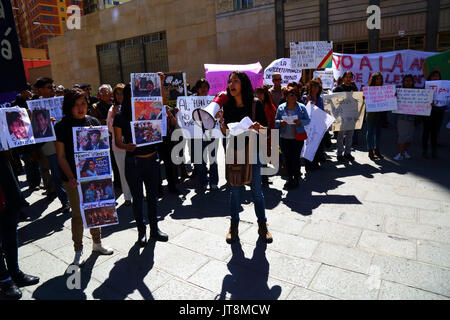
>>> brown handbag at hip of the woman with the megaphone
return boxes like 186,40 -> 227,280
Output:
225,99 -> 256,187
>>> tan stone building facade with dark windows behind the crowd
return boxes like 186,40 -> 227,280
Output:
50,0 -> 450,86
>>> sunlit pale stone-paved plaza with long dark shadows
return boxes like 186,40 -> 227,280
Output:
7,121 -> 450,300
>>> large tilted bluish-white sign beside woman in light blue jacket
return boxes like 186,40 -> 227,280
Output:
300,102 -> 335,161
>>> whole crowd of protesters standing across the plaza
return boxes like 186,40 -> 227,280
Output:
0,67 -> 445,298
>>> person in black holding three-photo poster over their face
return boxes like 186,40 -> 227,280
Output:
113,81 -> 169,246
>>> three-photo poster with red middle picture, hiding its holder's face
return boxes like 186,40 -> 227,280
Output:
130,73 -> 167,147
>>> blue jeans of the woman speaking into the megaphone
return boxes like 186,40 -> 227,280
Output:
228,161 -> 267,223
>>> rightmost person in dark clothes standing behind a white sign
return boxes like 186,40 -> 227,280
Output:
422,70 -> 446,159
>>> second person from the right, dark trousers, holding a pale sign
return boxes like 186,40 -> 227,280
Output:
394,74 -> 416,161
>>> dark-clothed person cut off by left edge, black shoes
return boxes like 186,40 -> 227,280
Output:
0,152 -> 39,299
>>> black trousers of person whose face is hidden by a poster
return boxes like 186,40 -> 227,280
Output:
125,154 -> 160,236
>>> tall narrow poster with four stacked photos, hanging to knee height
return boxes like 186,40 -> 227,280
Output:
72,126 -> 119,229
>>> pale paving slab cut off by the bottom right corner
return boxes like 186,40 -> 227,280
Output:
379,281 -> 450,300
